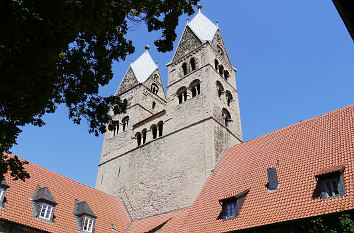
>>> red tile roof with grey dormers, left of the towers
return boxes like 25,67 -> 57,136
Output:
0,158 -> 130,233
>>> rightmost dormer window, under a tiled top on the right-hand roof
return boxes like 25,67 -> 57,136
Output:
316,165 -> 345,199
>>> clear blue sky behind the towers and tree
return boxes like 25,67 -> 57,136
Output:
12,0 -> 354,186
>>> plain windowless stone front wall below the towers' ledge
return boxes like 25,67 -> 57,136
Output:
96,119 -> 214,218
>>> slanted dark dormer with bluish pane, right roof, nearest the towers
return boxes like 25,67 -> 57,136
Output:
218,189 -> 249,220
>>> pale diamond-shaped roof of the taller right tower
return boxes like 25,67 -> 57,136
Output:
187,10 -> 218,43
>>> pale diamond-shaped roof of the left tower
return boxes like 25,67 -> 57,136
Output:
130,50 -> 157,83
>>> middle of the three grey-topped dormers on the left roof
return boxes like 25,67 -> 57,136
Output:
32,185 -> 57,222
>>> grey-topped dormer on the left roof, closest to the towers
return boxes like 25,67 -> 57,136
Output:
74,200 -> 96,233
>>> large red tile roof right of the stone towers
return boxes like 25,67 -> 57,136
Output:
179,105 -> 354,232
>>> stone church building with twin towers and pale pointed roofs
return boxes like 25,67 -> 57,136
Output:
96,10 -> 242,219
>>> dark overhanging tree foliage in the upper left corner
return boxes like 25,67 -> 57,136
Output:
0,0 -> 197,179
